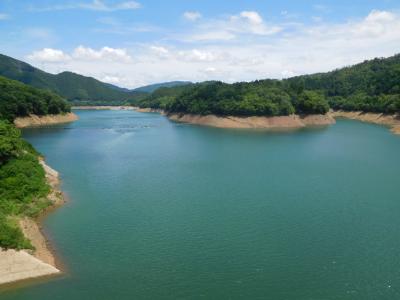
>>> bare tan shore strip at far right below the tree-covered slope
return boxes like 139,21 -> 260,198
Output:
330,111 -> 400,134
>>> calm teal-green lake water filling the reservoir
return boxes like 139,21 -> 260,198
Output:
0,111 -> 400,300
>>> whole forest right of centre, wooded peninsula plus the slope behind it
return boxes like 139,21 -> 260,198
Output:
136,55 -> 400,116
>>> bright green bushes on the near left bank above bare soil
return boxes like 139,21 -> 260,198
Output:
0,121 -> 50,249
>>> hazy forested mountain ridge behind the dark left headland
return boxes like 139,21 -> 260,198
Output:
0,54 -> 145,105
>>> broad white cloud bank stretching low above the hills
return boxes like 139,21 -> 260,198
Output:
23,10 -> 400,88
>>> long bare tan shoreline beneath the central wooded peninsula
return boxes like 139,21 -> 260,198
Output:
167,114 -> 335,130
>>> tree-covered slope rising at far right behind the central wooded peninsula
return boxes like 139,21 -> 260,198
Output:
285,55 -> 400,114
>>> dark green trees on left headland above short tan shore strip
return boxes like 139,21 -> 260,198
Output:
0,76 -> 71,121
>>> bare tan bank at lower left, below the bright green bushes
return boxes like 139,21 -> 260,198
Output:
0,159 -> 64,284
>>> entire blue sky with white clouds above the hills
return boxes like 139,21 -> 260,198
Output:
0,0 -> 400,88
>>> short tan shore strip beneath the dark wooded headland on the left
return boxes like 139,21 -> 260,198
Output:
14,113 -> 78,128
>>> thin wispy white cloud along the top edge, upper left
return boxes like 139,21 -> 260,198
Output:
31,0 -> 141,12
